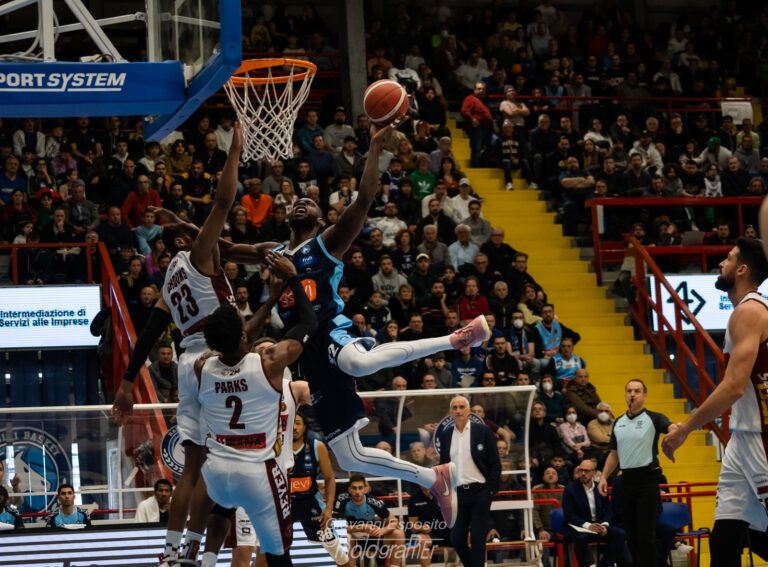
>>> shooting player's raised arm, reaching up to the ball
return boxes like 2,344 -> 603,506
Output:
321,122 -> 400,258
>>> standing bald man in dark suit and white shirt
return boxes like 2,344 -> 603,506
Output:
439,396 -> 501,567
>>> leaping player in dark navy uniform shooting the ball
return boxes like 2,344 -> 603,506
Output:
228,118 -> 490,526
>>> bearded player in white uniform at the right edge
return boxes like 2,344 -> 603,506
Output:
662,237 -> 768,567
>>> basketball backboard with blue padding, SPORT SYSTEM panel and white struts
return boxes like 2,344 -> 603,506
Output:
0,0 -> 242,140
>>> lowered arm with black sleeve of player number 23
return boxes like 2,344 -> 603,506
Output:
112,297 -> 173,425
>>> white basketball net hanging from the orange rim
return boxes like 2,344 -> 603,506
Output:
224,65 -> 314,162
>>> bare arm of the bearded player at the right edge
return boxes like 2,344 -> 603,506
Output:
661,301 -> 765,462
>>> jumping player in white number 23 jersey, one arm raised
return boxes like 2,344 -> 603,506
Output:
112,124 -> 250,566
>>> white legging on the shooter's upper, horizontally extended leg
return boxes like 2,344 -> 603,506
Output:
337,335 -> 453,380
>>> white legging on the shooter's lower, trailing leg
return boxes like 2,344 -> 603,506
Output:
330,431 -> 437,488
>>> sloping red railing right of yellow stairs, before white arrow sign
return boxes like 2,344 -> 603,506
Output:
628,236 -> 730,445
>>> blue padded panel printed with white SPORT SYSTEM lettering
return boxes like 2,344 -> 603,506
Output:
0,61 -> 185,117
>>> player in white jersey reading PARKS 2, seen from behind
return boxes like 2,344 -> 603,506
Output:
195,253 -> 318,567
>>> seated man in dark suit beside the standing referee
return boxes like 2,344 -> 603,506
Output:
563,459 -> 627,566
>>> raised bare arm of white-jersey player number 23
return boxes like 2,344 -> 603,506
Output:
190,122 -> 243,274
